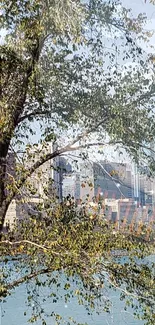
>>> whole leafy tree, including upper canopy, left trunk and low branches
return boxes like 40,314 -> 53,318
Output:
0,0 -> 155,321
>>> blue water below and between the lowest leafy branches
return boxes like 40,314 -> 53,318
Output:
0,254 -> 154,325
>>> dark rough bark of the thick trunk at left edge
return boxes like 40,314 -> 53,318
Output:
0,40 -> 41,238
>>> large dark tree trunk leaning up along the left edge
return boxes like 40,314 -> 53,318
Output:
0,41 -> 44,237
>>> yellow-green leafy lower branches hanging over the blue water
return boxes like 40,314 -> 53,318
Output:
1,201 -> 154,324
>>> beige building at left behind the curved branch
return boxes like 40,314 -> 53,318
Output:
5,143 -> 61,227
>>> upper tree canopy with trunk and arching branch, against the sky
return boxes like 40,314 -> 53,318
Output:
0,1 -> 154,228
